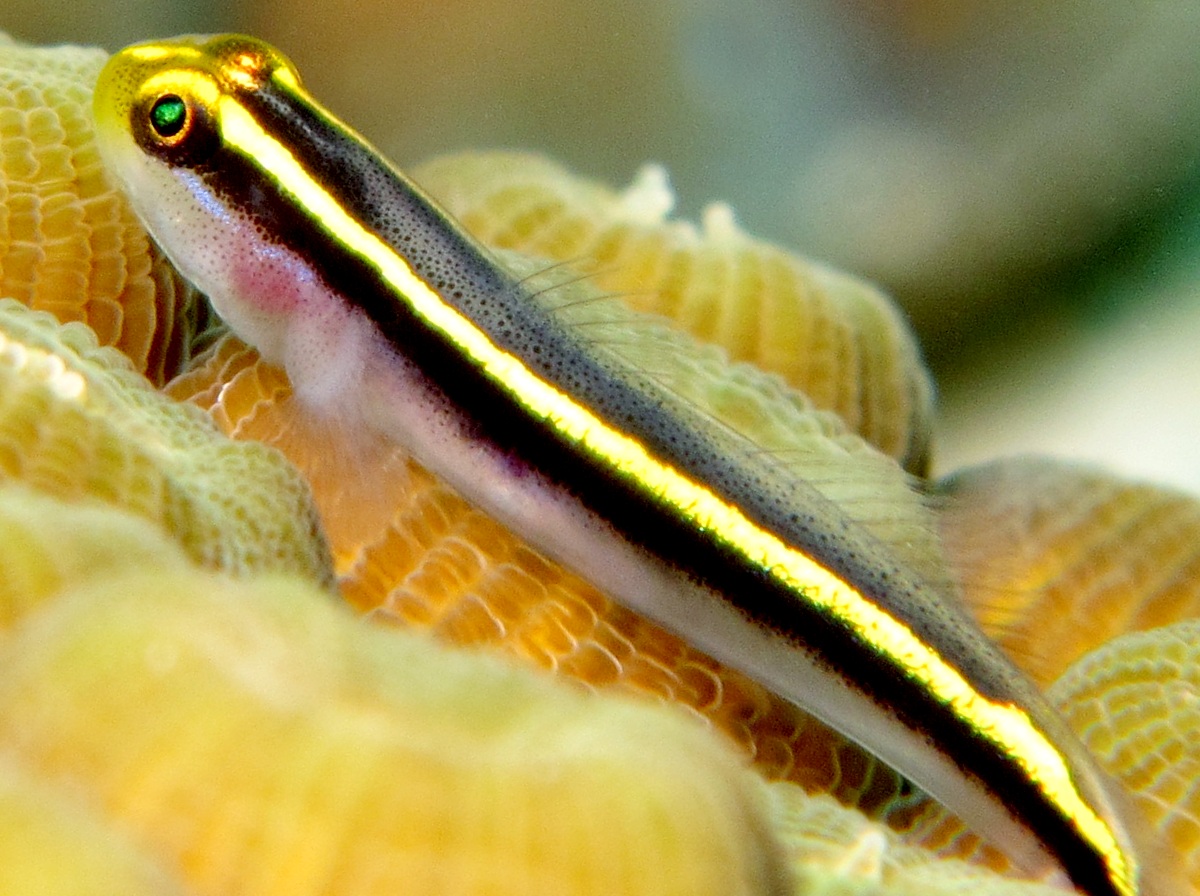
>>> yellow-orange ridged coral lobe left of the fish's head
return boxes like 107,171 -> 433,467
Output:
0,34 -> 203,384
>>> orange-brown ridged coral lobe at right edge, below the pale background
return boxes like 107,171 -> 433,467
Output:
938,457 -> 1200,686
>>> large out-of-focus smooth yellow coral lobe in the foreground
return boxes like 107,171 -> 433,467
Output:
0,489 -> 788,896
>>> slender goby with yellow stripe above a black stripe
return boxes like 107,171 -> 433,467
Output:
95,36 -> 1146,896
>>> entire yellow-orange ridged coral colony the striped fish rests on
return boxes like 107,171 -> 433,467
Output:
0,33 -> 1200,896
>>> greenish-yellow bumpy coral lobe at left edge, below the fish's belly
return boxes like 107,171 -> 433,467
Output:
0,300 -> 331,583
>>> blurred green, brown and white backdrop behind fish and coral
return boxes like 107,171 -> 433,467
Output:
9,0 -> 1200,492
